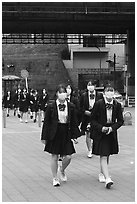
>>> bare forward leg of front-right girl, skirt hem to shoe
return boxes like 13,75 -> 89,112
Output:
100,156 -> 110,179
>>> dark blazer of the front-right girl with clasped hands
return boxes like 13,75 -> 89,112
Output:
91,98 -> 124,141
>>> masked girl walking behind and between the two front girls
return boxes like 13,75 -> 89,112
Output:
80,80 -> 103,158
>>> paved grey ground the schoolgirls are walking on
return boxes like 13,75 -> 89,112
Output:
2,108 -> 135,202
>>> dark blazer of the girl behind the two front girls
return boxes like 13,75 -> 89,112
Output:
80,91 -> 103,131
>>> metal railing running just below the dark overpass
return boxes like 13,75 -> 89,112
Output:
2,33 -> 127,44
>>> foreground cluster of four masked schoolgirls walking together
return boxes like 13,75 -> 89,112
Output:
41,81 -> 124,189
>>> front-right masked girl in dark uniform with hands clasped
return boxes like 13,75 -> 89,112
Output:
91,86 -> 124,189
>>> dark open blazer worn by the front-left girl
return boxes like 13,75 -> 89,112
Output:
41,101 -> 80,140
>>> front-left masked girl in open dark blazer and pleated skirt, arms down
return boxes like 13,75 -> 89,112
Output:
41,84 -> 80,186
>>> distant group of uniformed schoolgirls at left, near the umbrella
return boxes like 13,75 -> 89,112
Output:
2,88 -> 49,123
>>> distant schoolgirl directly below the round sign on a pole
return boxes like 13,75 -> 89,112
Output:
19,88 -> 29,123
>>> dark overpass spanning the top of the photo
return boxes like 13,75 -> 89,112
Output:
2,2 -> 135,34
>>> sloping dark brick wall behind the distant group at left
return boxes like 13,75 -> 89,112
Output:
2,45 -> 71,97
